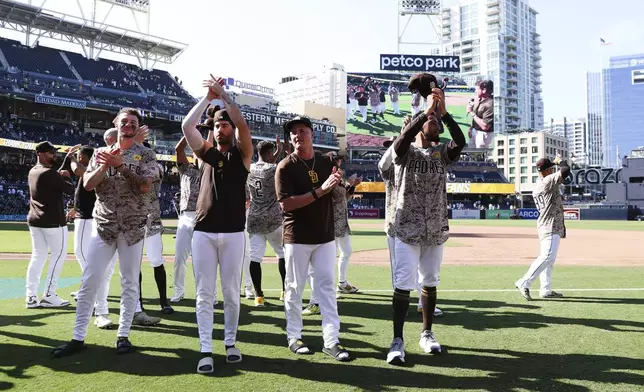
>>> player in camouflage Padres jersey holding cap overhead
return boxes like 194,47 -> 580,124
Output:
381,74 -> 466,364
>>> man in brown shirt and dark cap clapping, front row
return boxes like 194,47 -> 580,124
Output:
275,117 -> 350,361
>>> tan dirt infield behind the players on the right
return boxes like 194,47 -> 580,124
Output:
351,224 -> 644,266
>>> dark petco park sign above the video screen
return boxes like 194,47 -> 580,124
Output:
380,54 -> 461,72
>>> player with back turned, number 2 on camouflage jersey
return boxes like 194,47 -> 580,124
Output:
246,136 -> 286,306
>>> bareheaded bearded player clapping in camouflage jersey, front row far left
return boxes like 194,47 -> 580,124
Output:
52,108 -> 157,358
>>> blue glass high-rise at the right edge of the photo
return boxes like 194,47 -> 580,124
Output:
586,54 -> 644,167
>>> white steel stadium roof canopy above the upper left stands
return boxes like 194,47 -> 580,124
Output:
0,0 -> 188,64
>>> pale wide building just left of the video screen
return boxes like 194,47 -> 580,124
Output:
275,64 -> 347,112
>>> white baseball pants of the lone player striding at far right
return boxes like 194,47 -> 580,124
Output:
516,234 -> 561,295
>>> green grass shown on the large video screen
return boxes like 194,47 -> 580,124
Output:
347,93 -> 472,142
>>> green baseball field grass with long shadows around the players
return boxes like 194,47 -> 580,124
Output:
0,220 -> 644,391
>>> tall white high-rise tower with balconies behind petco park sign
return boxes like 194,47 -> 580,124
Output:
441,0 -> 543,132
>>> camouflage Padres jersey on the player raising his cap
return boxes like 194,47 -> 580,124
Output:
392,144 -> 452,246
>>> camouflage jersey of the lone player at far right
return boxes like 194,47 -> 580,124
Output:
532,172 -> 565,237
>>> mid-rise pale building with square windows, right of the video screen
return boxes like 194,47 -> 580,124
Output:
492,132 -> 569,194
